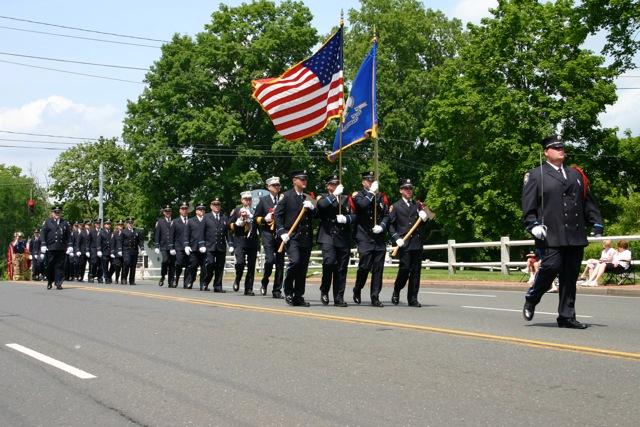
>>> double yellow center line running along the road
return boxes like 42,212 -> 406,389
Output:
10,283 -> 640,362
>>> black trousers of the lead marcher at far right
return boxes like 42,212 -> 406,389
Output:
525,246 -> 584,320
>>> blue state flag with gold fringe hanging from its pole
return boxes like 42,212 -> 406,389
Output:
328,41 -> 378,161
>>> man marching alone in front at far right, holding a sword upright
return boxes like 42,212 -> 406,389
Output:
522,135 -> 604,329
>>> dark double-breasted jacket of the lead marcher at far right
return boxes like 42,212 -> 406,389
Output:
522,163 -> 602,248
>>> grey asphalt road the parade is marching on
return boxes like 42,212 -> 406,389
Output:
0,282 -> 640,426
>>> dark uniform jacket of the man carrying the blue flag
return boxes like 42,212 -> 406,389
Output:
353,188 -> 389,250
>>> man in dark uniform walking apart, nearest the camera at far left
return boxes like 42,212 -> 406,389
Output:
40,206 -> 73,289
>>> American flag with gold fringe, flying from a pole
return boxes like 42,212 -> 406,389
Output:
252,27 -> 344,141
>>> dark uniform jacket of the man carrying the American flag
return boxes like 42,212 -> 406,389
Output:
316,194 -> 355,248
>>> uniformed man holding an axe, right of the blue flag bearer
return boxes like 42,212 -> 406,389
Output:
389,179 -> 428,307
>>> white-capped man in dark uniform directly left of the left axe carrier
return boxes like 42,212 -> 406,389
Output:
256,176 -> 284,298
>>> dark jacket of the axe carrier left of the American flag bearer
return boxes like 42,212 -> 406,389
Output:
275,188 -> 317,247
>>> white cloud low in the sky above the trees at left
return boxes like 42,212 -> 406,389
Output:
0,95 -> 124,183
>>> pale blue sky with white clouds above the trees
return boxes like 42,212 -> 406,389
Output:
0,0 -> 640,184
